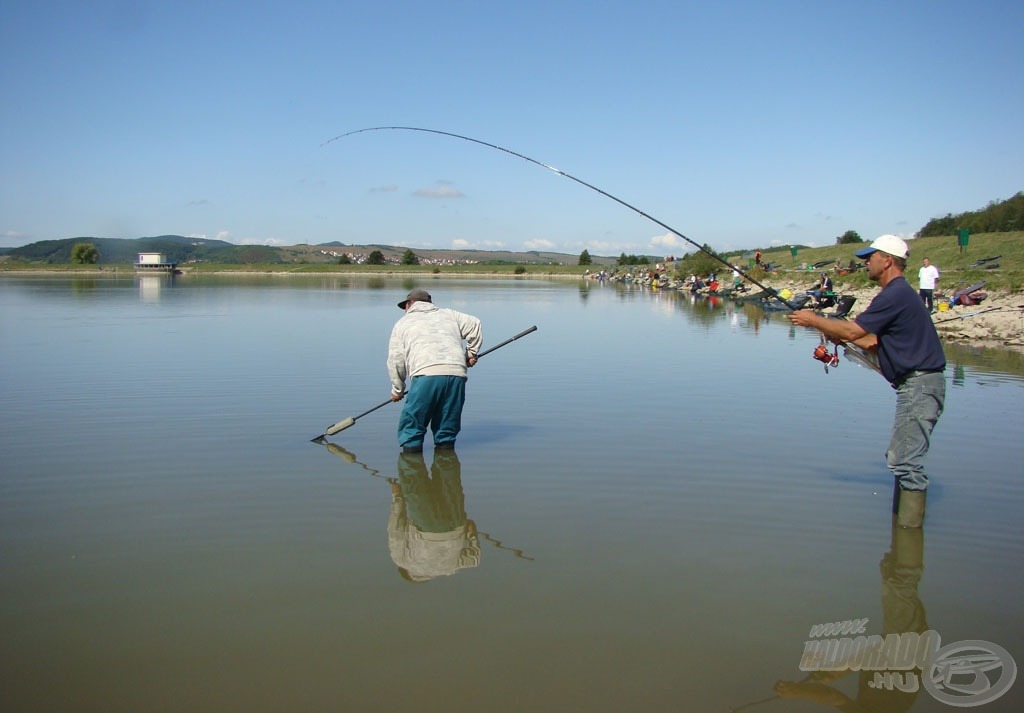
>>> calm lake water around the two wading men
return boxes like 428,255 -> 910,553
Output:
0,276 -> 1024,713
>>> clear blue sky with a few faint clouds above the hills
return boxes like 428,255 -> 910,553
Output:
0,0 -> 1024,255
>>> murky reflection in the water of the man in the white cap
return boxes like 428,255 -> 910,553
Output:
775,522 -> 928,713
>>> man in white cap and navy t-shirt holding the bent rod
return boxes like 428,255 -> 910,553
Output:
790,236 -> 946,528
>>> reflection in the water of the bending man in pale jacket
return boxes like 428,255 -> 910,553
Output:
387,450 -> 480,582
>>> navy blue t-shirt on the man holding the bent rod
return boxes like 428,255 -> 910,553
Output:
854,276 -> 946,383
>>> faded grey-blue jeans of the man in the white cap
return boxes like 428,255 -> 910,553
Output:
886,372 -> 946,491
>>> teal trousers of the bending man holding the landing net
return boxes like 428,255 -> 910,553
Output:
398,376 -> 466,447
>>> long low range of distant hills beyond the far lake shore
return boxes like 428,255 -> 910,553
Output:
3,236 -> 615,266
